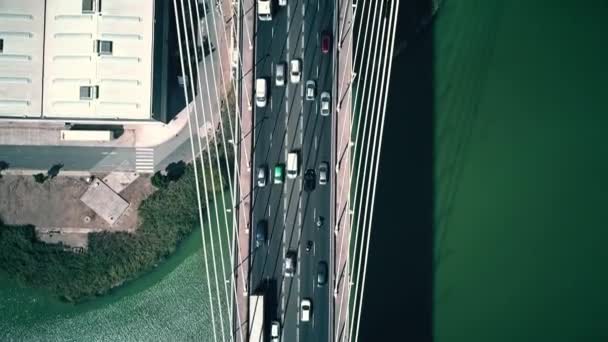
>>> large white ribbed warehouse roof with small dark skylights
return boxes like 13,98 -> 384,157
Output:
0,0 -> 154,120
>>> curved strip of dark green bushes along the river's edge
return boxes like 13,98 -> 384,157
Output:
0,155 -> 226,302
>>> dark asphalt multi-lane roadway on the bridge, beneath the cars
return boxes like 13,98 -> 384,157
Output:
250,0 -> 335,341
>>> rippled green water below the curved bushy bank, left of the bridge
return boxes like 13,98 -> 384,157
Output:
0,199 -> 230,342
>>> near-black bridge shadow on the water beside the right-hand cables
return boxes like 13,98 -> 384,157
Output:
359,0 -> 435,342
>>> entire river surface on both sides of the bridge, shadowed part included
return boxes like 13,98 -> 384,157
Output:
0,0 -> 608,342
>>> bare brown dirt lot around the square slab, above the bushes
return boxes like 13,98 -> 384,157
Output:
0,174 -> 154,233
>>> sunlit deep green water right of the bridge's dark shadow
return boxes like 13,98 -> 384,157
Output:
434,0 -> 608,342
